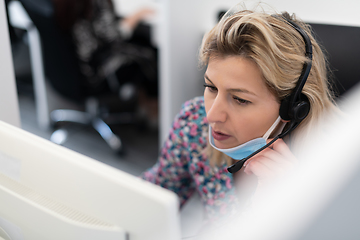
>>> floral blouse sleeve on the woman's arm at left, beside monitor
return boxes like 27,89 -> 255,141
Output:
141,99 -> 205,206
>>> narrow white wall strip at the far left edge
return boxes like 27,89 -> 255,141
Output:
0,0 -> 20,127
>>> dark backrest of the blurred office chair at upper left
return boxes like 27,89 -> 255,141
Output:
20,0 -> 86,101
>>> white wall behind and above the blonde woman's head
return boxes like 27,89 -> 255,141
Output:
158,0 -> 360,143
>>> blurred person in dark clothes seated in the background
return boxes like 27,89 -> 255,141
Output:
53,0 -> 158,126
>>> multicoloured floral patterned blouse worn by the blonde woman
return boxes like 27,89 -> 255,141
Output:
141,97 -> 238,220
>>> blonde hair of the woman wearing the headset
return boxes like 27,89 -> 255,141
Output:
199,7 -> 335,165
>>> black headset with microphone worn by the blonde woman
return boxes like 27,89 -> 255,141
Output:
227,15 -> 312,173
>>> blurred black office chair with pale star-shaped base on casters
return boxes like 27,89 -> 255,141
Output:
20,0 -> 136,153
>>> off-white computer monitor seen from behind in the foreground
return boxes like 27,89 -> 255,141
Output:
0,122 -> 181,240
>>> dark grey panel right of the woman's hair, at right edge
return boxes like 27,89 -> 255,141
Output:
310,23 -> 360,97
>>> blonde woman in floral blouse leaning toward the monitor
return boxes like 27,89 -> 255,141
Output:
142,7 -> 335,223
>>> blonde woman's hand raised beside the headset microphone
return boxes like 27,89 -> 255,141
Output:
244,139 -> 297,185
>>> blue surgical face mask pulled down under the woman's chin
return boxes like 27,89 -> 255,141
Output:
209,116 -> 284,160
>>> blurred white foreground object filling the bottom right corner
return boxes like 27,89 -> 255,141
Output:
204,83 -> 360,240
